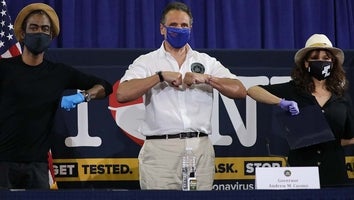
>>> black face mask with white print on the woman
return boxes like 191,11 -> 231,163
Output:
308,61 -> 333,81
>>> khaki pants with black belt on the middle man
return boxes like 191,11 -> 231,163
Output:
139,137 -> 215,190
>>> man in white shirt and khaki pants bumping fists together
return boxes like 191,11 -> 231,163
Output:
117,2 -> 246,190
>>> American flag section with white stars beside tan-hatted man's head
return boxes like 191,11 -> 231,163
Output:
0,0 -> 21,59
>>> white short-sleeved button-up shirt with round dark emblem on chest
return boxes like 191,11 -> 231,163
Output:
120,44 -> 237,136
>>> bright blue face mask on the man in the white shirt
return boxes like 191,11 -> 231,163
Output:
165,26 -> 191,49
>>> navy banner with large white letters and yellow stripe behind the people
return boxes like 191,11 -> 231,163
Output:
47,49 -> 354,190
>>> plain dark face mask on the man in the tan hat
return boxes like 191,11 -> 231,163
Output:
23,33 -> 52,55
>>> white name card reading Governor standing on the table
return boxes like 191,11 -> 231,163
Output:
256,167 -> 320,190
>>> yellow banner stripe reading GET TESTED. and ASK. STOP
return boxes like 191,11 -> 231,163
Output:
53,156 -> 354,181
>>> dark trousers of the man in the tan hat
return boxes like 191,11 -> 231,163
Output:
0,161 -> 49,189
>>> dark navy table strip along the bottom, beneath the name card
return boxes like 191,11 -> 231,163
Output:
0,187 -> 354,200
